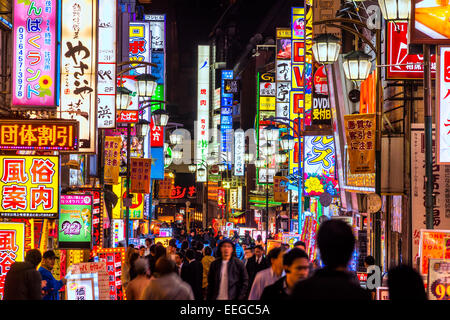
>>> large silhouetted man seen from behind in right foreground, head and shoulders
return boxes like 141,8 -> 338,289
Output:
292,219 -> 370,300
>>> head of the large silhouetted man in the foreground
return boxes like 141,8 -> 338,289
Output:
317,219 -> 355,268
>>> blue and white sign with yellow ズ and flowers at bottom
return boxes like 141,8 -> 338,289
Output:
303,136 -> 338,197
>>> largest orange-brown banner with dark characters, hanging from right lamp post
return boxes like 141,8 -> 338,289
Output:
344,114 -> 376,174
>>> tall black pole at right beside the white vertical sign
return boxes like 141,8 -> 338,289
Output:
423,44 -> 433,229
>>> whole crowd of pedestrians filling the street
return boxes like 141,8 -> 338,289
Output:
4,220 -> 426,301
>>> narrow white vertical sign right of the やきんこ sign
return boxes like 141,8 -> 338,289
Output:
97,0 -> 117,129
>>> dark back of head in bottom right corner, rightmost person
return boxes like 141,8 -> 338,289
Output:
387,265 -> 427,300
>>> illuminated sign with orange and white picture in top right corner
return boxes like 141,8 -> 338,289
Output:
409,0 -> 450,44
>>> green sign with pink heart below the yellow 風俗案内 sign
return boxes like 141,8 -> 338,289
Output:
58,194 -> 92,249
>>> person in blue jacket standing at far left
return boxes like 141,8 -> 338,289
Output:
38,250 -> 67,300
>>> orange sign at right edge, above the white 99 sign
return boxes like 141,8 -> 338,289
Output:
419,229 -> 450,274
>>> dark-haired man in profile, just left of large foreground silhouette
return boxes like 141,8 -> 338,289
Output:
260,248 -> 309,301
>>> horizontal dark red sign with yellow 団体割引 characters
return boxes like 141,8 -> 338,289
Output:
0,120 -> 78,151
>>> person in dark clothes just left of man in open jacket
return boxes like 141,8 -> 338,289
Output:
181,249 -> 203,300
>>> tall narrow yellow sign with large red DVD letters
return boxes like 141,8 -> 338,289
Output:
289,8 -> 306,175
